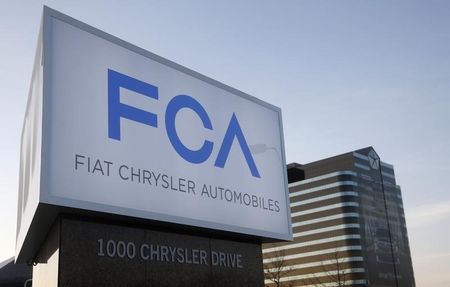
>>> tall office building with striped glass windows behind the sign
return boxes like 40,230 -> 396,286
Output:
263,147 -> 415,287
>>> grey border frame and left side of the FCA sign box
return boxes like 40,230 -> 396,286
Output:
16,6 -> 293,262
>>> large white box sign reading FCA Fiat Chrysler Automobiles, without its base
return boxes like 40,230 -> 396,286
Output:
18,8 -> 292,264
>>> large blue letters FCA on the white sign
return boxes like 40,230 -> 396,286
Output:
108,69 -> 260,178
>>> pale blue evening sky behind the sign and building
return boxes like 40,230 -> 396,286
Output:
0,0 -> 450,287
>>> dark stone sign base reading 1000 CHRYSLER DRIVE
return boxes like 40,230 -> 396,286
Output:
33,217 -> 264,287
